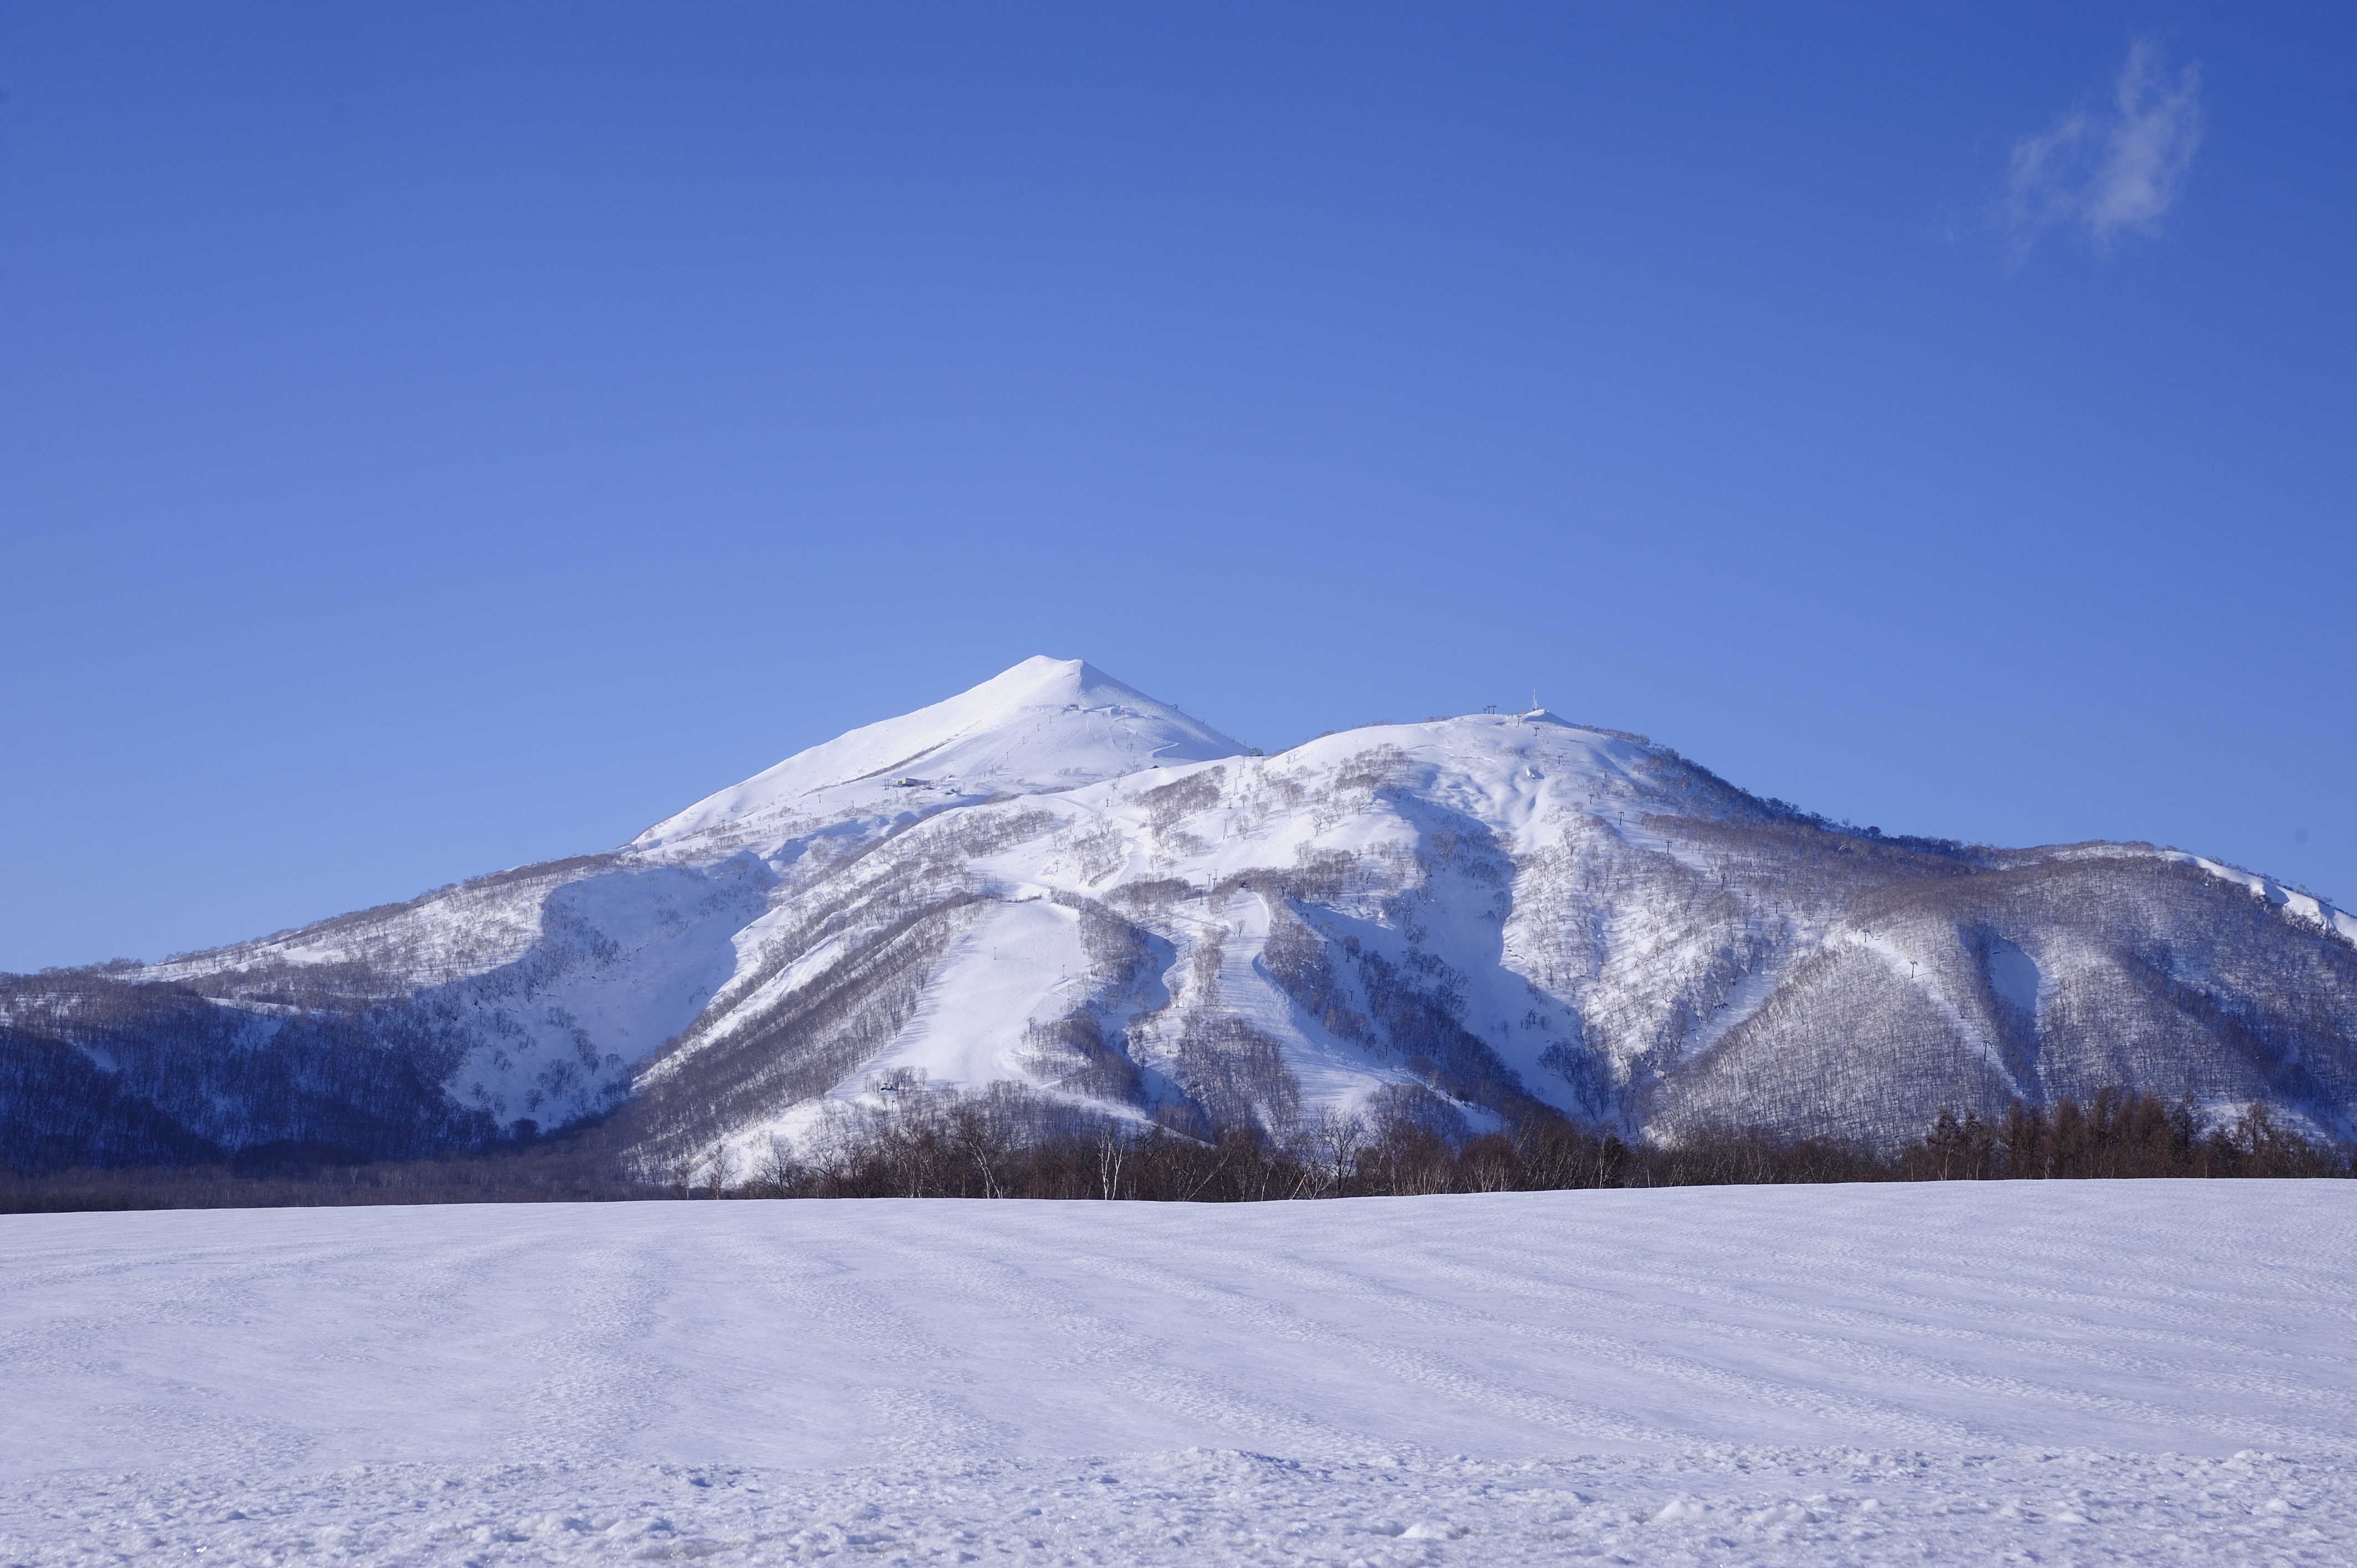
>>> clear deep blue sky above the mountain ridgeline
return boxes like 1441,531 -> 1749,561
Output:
0,2 -> 2357,969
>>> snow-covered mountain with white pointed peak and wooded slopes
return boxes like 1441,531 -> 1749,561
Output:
0,658 -> 2357,1165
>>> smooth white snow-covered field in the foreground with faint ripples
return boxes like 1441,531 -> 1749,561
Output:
0,1182 -> 2357,1563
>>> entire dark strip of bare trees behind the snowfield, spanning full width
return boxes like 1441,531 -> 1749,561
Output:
14,1077 -> 2357,1212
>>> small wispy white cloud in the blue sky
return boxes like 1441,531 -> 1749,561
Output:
2006,38 -> 2201,259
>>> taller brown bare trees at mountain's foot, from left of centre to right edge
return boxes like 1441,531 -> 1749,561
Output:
672,1085 -> 2357,1203
